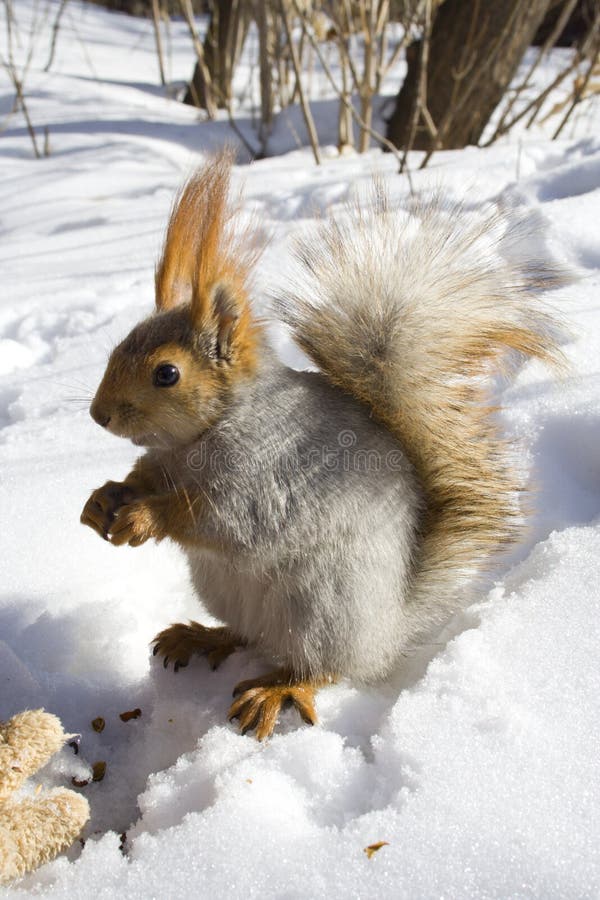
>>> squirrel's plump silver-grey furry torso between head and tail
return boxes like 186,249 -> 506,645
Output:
175,362 -> 422,680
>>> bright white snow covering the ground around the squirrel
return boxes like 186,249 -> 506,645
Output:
0,0 -> 600,900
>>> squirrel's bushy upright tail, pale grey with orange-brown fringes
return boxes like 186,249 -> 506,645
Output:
278,193 -> 570,636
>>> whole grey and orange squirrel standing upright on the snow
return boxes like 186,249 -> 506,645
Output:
81,153 -> 568,740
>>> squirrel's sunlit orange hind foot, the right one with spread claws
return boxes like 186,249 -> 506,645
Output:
228,669 -> 326,741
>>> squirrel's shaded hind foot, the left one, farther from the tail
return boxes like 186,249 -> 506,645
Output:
152,622 -> 245,672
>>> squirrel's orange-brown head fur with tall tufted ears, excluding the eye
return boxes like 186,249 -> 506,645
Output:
91,151 -> 261,446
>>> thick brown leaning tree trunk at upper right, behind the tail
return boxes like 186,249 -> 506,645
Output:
387,0 -> 550,153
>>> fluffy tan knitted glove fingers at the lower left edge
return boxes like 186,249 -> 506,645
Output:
0,709 -> 90,884
